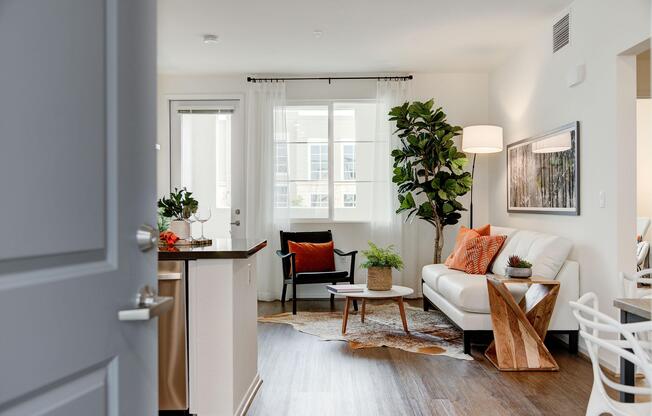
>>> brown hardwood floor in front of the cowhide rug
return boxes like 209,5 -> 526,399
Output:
247,300 -> 593,416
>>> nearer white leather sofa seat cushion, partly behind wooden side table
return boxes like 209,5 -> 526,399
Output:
432,273 -> 528,313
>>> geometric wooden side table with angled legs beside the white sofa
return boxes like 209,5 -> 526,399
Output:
484,276 -> 559,371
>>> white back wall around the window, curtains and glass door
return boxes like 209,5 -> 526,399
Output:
158,73 -> 489,297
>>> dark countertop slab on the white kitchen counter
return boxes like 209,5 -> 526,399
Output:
158,238 -> 267,260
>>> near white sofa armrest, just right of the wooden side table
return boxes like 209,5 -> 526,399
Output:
548,260 -> 580,331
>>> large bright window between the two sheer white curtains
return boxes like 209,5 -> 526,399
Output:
275,101 -> 376,222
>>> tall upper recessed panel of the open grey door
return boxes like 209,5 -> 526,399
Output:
0,0 -> 106,260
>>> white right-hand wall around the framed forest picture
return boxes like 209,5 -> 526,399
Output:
489,0 -> 650,366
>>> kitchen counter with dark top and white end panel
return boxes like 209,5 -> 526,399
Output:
158,238 -> 267,416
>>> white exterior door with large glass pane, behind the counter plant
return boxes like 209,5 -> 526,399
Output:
170,99 -> 245,238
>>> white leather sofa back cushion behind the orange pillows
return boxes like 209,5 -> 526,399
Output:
491,226 -> 573,279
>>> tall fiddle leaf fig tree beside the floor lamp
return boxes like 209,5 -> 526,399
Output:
389,100 -> 473,263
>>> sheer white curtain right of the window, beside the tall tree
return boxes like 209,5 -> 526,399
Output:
370,81 -> 421,297
